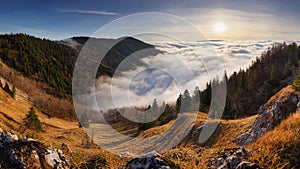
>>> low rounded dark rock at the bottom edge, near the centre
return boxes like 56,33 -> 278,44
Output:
125,156 -> 170,169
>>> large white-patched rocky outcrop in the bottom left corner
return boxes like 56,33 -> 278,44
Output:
0,129 -> 70,169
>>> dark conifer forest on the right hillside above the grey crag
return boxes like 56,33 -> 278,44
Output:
199,43 -> 300,119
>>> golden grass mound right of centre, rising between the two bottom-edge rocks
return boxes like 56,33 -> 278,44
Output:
163,113 -> 257,169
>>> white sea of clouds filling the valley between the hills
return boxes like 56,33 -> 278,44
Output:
93,40 -> 288,110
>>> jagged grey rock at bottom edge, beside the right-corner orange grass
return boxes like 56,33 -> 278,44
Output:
207,147 -> 260,169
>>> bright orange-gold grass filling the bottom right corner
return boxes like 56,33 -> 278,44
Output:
248,112 -> 300,168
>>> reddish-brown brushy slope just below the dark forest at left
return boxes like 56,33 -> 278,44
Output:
0,61 -> 76,121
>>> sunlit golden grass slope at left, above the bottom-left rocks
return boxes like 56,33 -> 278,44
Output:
0,78 -> 127,168
